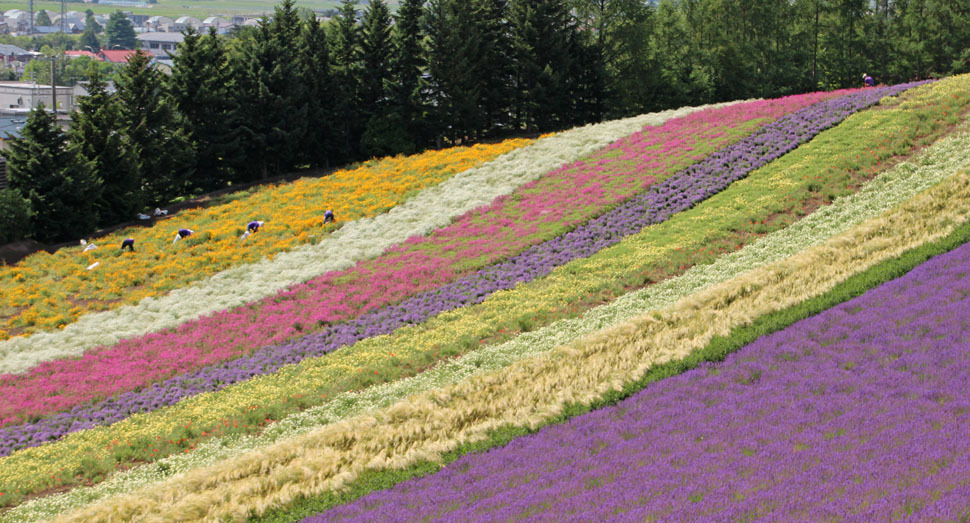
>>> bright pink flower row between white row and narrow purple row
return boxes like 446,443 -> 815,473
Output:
0,91 -> 845,426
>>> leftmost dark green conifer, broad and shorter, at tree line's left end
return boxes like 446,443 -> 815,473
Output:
6,105 -> 101,241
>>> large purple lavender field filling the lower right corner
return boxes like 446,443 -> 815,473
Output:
310,244 -> 970,521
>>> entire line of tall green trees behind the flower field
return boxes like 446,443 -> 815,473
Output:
0,0 -> 970,246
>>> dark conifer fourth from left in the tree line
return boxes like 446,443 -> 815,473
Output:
168,28 -> 242,191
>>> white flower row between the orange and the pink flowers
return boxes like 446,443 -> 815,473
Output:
0,104 -> 729,373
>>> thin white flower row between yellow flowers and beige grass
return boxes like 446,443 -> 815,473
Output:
20,125 -> 970,521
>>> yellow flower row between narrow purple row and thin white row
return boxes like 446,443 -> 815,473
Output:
0,78 -> 956,500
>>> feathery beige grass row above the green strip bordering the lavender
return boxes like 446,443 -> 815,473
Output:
63,171 -> 970,521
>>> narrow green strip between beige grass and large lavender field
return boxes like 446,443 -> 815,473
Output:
250,210 -> 970,523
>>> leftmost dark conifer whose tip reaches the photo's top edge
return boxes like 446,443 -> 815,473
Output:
235,0 -> 307,179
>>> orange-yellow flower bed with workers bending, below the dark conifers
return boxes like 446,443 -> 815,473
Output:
0,139 -> 532,340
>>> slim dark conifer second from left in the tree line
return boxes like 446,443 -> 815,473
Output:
69,63 -> 145,225
